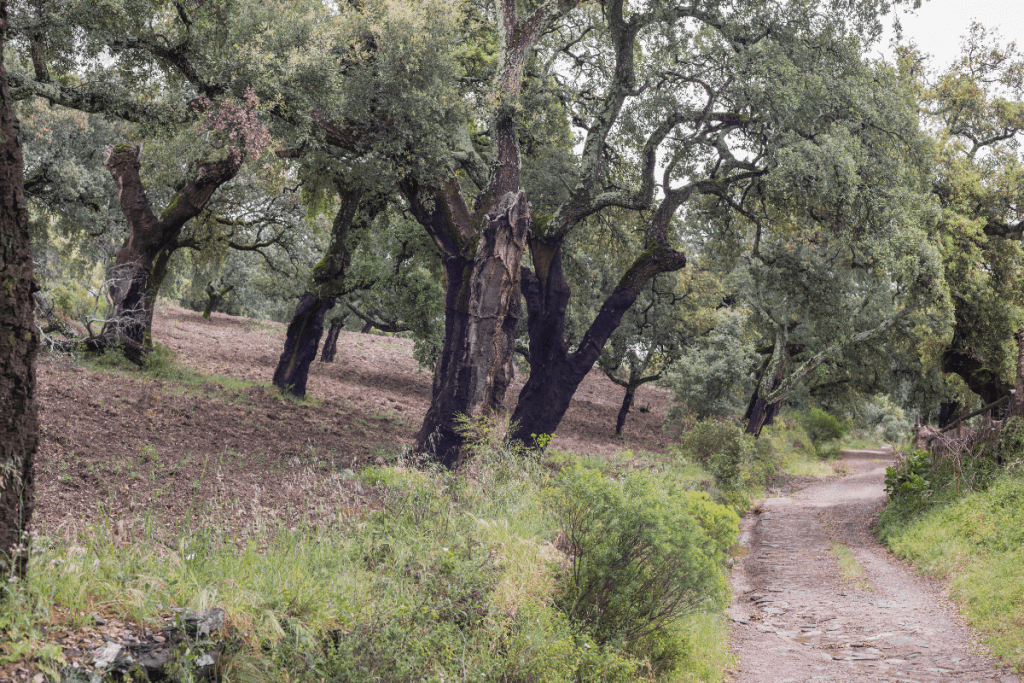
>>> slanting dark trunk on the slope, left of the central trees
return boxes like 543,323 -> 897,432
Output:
273,188 -> 386,398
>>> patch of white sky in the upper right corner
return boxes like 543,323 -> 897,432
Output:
870,0 -> 1024,69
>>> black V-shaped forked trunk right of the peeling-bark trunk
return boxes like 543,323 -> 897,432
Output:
509,238 -> 686,449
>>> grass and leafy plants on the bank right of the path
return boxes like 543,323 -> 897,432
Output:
879,418 -> 1024,671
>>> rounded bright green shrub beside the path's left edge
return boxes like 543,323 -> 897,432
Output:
548,467 -> 737,668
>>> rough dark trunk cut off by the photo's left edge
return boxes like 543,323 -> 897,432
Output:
0,2 -> 39,581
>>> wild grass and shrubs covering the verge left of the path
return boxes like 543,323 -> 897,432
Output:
0,347 -> 847,681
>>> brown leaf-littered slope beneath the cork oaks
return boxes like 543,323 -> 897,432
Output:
34,305 -> 669,538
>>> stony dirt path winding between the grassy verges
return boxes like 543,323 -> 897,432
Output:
729,451 -> 1020,683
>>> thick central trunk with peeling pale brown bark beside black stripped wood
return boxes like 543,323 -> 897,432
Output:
416,191 -> 530,467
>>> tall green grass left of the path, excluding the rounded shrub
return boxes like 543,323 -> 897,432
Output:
0,446 -> 749,683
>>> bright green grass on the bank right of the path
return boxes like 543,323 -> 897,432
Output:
882,475 -> 1024,672
